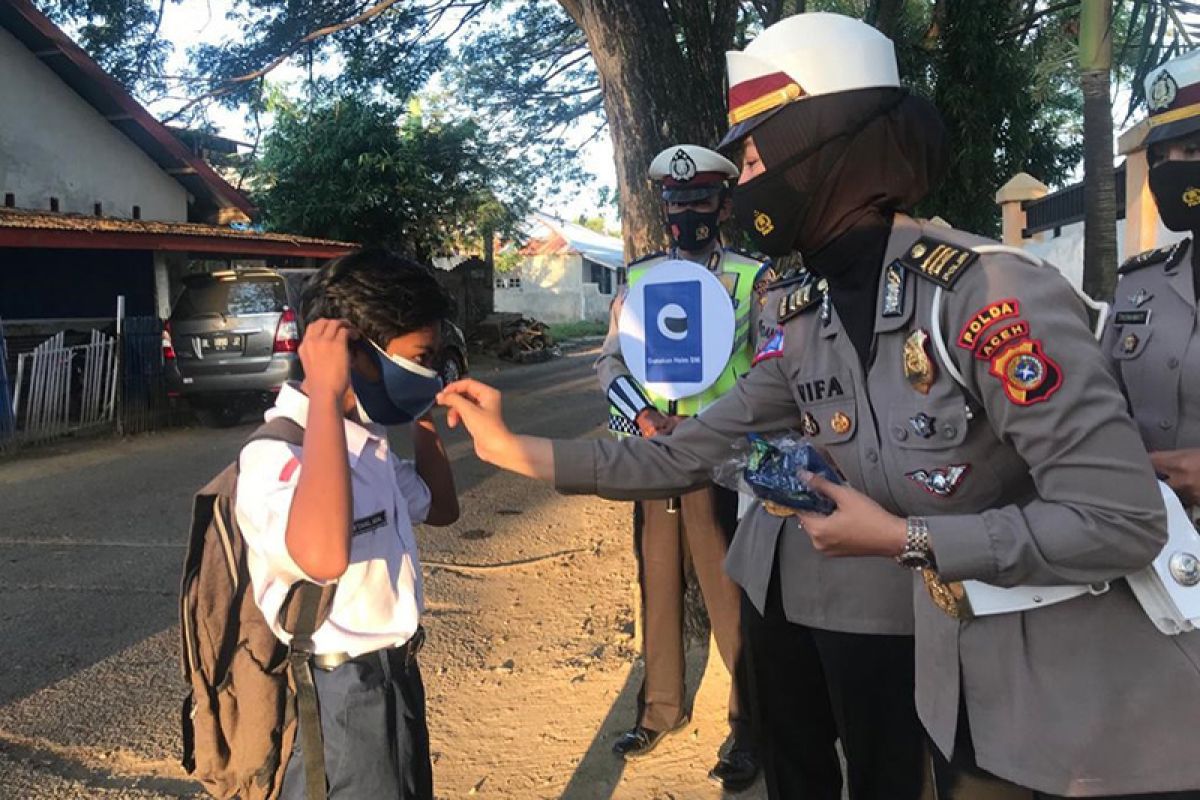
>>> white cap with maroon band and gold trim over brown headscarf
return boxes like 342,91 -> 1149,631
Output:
719,12 -> 900,149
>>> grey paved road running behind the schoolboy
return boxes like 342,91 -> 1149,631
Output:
0,354 -> 604,800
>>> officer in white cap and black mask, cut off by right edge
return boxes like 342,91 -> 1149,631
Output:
1103,52 -> 1200,506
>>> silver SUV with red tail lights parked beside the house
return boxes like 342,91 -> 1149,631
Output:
163,269 -> 302,426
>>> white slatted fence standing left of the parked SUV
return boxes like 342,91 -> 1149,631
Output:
8,331 -> 120,444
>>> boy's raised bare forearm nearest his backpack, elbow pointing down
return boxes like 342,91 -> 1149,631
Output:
286,393 -> 354,581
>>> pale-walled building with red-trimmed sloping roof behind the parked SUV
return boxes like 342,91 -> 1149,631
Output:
0,0 -> 353,335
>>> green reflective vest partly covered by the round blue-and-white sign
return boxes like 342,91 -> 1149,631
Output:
608,249 -> 762,424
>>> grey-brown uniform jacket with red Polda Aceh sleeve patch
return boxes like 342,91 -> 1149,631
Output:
554,216 -> 1200,795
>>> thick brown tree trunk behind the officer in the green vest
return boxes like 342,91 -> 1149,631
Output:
559,0 -> 737,260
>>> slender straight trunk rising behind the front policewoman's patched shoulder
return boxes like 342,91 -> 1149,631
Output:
1079,0 -> 1117,300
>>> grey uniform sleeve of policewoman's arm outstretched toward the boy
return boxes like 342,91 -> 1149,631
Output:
554,359 -> 798,500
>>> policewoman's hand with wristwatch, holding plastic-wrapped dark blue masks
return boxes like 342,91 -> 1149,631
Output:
796,473 -> 906,557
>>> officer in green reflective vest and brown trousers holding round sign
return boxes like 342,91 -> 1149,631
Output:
596,144 -> 766,790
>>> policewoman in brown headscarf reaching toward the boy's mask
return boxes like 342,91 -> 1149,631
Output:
442,13 -> 1200,800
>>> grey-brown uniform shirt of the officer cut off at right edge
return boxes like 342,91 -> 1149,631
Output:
1103,240 -> 1200,451
